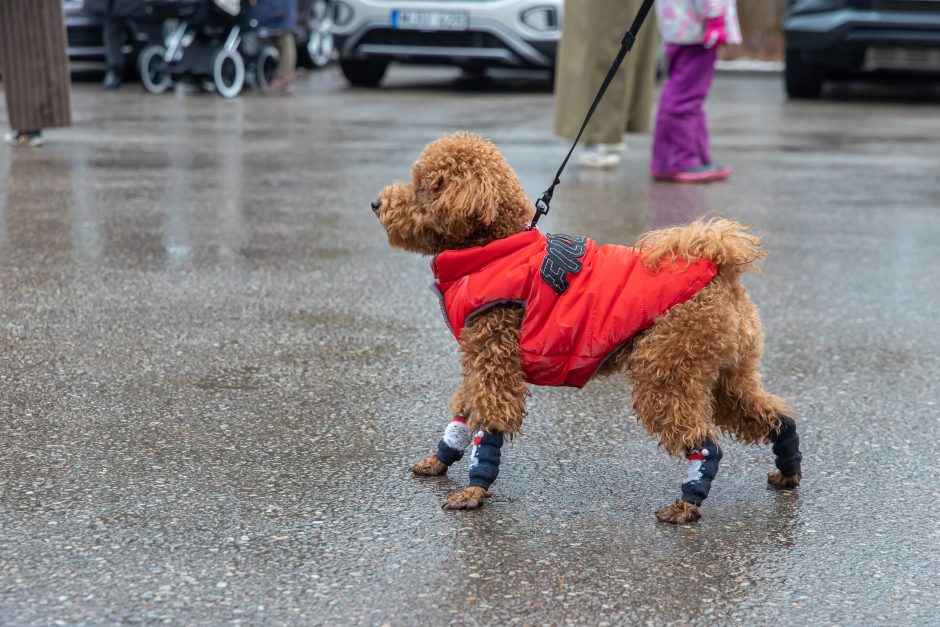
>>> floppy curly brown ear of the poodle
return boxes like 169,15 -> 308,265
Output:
428,155 -> 502,239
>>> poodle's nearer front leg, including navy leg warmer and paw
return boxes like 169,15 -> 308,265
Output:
444,307 -> 528,509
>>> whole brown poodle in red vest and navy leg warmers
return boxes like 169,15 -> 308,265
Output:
372,133 -> 802,523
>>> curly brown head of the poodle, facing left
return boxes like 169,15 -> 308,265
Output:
372,133 -> 534,255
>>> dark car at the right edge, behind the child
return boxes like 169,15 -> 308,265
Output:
784,0 -> 940,98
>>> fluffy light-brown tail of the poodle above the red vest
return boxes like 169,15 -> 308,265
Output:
636,218 -> 765,277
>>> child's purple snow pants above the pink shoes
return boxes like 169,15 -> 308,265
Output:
651,44 -> 716,176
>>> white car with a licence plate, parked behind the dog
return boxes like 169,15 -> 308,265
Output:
333,0 -> 564,87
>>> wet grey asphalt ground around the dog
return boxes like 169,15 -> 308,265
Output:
0,70 -> 940,625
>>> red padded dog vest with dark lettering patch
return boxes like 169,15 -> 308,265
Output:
431,230 -> 717,388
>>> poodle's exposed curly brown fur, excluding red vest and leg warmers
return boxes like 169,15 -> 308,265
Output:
374,133 -> 799,523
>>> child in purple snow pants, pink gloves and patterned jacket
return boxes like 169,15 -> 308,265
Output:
650,0 -> 741,183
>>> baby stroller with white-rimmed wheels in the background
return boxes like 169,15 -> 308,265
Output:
138,0 -> 279,98
